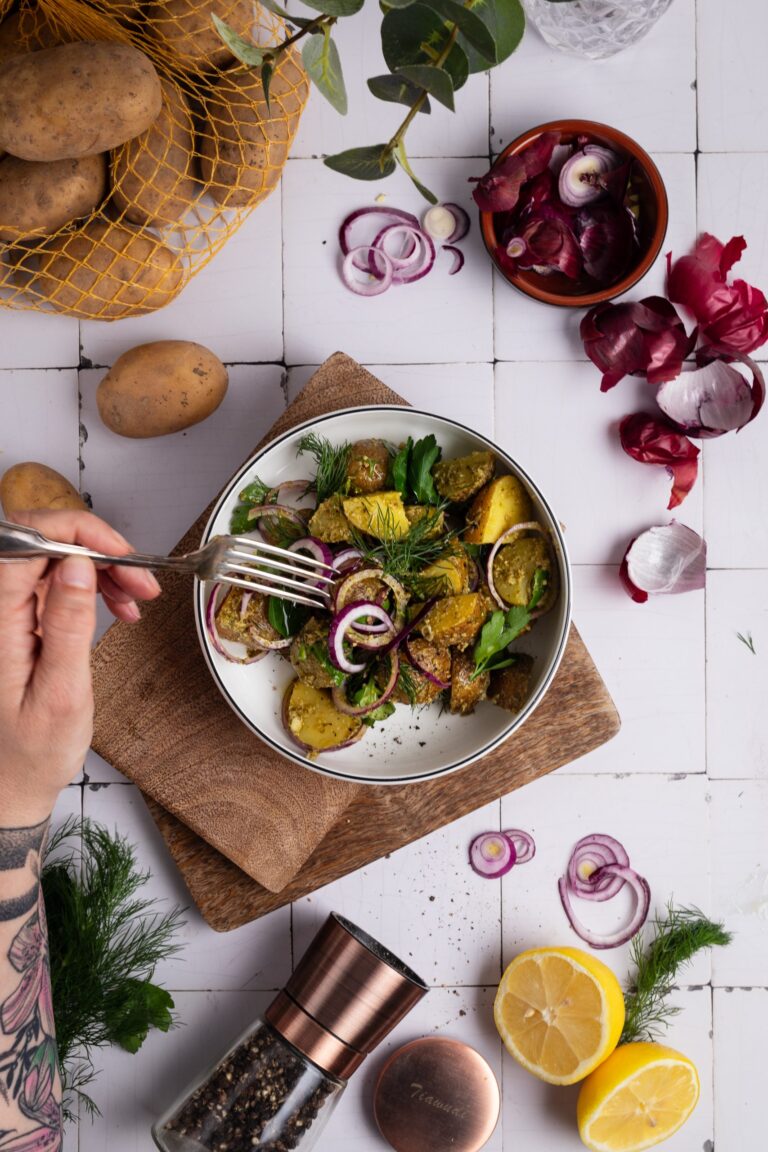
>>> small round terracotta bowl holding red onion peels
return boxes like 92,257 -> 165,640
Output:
480,120 -> 669,308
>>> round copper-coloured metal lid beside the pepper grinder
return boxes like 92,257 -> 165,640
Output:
373,1037 -> 500,1152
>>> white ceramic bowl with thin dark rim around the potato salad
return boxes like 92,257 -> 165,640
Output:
195,406 -> 571,785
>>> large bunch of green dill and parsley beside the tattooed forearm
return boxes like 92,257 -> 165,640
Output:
41,818 -> 183,1117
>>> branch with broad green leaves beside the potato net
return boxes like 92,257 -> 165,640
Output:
213,0 -> 525,204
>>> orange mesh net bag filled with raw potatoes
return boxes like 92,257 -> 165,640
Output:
0,0 -> 309,320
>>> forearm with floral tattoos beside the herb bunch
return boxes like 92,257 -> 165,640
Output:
0,821 -> 61,1152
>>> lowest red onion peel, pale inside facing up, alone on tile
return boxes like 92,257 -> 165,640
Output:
619,520 -> 707,604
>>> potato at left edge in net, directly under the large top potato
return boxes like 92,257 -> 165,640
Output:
0,154 -> 107,244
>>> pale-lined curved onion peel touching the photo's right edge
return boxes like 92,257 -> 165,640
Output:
656,356 -> 766,437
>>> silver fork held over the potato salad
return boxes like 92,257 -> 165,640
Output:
0,520 -> 336,608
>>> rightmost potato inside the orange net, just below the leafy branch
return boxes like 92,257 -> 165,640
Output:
200,48 -> 309,209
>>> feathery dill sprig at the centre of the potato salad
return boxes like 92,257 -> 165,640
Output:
351,505 -> 456,594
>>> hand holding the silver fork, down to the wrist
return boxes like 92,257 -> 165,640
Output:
0,511 -> 160,827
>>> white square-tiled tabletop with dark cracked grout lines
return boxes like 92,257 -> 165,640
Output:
0,0 -> 768,1152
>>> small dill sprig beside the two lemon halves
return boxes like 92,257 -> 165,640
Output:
618,903 -> 732,1044
